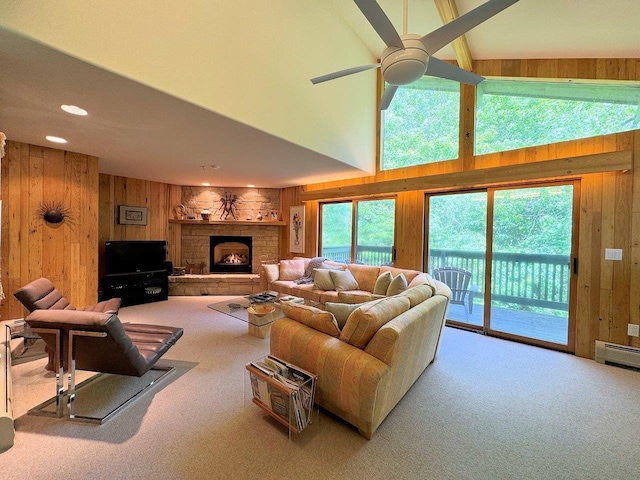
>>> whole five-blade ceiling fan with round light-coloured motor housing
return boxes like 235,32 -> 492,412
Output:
311,0 -> 519,110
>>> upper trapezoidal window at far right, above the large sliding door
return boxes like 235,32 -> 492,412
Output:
475,79 -> 640,155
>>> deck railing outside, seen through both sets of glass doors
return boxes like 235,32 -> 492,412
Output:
322,245 -> 570,311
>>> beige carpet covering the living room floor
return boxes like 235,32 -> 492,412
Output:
0,297 -> 640,480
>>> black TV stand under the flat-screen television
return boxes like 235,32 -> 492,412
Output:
102,269 -> 169,307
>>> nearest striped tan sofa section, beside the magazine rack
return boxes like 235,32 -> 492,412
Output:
270,258 -> 451,439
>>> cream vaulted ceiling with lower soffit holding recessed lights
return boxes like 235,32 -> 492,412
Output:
0,0 -> 640,187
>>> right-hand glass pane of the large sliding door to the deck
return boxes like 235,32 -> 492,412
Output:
490,185 -> 573,345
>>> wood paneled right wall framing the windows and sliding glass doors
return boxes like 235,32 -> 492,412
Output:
283,59 -> 640,358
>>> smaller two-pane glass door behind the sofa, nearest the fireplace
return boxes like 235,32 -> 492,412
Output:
320,199 -> 395,265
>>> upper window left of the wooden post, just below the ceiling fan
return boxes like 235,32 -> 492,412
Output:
380,77 -> 460,170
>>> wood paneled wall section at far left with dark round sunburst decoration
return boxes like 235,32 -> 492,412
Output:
1,141 -> 98,319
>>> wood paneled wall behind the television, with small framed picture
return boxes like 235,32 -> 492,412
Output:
99,174 -> 182,278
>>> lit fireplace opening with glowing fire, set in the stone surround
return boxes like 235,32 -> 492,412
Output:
209,235 -> 252,273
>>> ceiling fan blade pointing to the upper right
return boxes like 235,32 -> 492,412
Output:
420,0 -> 519,55
